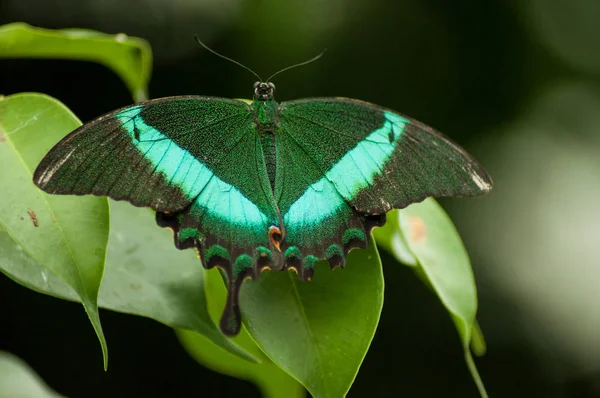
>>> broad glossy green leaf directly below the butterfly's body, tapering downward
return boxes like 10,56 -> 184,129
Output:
241,239 -> 383,398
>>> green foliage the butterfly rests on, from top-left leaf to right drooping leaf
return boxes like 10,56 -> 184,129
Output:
0,24 -> 485,397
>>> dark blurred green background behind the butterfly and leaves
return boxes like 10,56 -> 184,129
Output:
0,0 -> 600,398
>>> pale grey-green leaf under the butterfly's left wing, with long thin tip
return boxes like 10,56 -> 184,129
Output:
100,201 -> 258,363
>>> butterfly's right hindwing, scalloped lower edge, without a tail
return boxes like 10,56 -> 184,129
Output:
275,119 -> 380,279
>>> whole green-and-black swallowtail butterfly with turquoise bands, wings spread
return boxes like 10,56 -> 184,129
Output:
34,77 -> 492,335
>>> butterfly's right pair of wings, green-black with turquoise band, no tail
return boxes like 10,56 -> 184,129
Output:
275,98 -> 492,278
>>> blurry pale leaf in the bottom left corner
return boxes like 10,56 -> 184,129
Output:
0,351 -> 62,398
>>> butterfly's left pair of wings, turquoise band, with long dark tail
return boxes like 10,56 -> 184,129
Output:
34,96 -> 280,334
